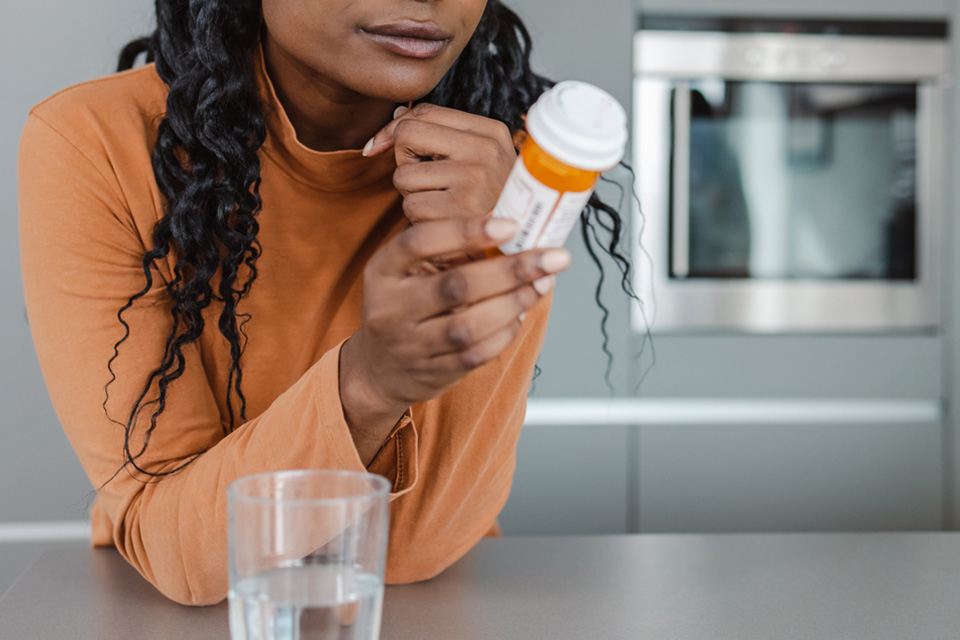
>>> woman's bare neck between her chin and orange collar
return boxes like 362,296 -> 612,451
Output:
263,37 -> 396,151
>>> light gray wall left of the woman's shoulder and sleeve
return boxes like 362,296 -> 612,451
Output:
0,0 -> 152,523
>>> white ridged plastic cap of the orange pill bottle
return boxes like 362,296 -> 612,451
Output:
527,80 -> 627,171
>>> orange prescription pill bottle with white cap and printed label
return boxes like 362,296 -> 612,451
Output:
493,80 -> 627,254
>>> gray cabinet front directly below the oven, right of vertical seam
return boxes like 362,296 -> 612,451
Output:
637,423 -> 942,533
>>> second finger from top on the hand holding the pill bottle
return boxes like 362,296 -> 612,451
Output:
416,249 -> 570,318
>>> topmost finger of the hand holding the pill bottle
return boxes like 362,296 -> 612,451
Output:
368,218 -> 518,277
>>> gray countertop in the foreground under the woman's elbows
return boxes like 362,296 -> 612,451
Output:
0,533 -> 960,640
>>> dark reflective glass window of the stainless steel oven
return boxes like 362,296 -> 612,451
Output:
670,79 -> 917,280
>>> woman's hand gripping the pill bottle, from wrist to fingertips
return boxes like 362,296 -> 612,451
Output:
340,218 -> 570,463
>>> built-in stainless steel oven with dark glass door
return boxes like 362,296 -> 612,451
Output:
633,16 -> 948,332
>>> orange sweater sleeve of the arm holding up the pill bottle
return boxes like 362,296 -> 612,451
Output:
19,116 -> 415,604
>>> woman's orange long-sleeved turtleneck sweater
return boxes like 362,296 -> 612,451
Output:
19,53 -> 549,604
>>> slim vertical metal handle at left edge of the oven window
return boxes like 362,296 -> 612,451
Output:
670,81 -> 690,279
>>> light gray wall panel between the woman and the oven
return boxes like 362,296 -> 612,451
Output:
507,0 -> 649,397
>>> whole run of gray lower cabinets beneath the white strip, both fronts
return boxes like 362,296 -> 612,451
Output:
500,421 -> 943,535
